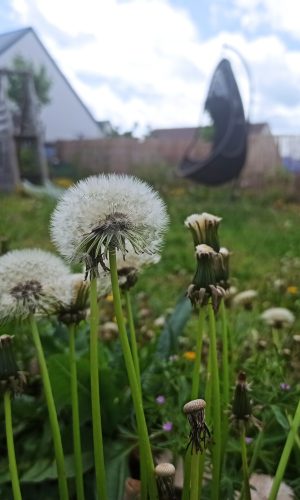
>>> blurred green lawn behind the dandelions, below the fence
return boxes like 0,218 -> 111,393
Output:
0,182 -> 300,313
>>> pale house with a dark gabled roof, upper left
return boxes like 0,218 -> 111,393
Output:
0,28 -> 103,143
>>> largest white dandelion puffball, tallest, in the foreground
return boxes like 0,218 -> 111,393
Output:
51,174 -> 168,268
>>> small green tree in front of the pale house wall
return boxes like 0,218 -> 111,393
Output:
7,55 -> 52,111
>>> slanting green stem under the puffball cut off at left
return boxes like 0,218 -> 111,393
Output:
30,315 -> 69,500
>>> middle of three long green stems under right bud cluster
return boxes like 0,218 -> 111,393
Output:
208,304 -> 222,500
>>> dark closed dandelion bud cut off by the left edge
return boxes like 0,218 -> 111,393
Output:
0,335 -> 26,394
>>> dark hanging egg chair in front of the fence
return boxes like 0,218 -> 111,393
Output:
178,59 -> 248,186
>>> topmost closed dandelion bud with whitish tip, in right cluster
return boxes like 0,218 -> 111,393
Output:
184,212 -> 222,252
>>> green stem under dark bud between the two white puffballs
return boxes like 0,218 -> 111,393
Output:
68,323 -> 84,500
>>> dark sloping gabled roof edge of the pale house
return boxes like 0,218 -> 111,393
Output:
0,27 -> 98,131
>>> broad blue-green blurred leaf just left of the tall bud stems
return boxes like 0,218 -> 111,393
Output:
156,296 -> 192,359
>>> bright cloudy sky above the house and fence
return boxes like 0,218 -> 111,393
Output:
0,0 -> 300,135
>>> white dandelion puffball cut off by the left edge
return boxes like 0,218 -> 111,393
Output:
0,249 -> 71,319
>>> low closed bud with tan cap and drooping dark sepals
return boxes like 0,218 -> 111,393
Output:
183,399 -> 211,453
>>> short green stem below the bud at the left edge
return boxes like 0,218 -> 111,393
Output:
4,391 -> 22,500
